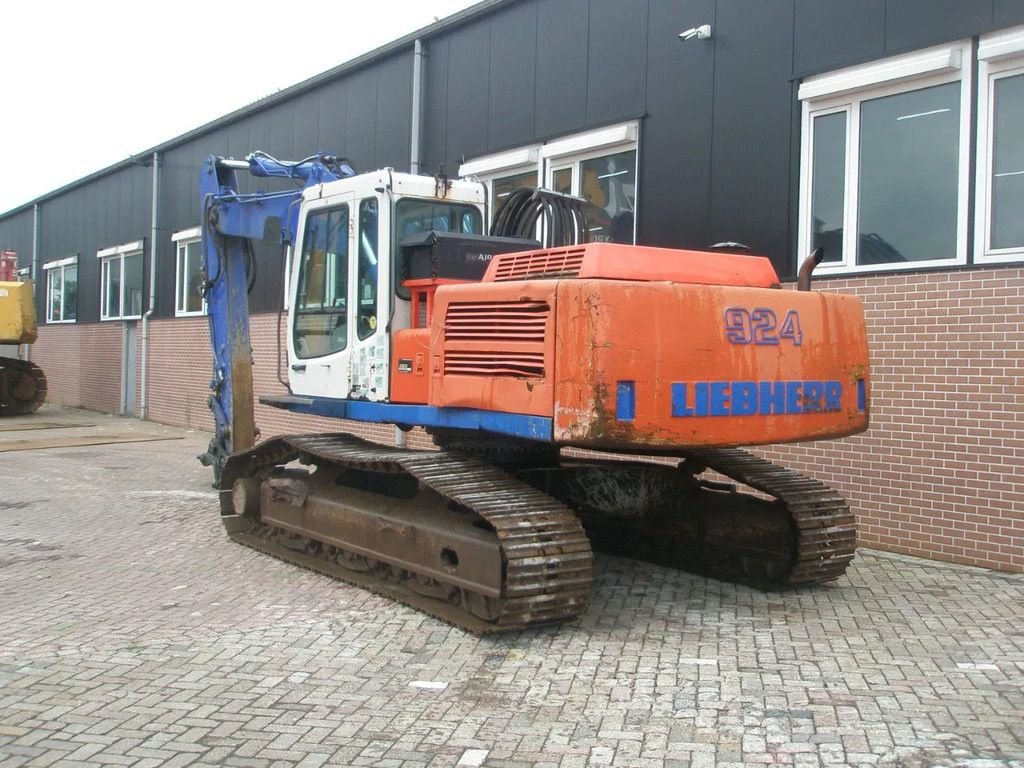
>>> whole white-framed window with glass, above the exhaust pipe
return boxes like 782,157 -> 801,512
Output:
798,43 -> 971,273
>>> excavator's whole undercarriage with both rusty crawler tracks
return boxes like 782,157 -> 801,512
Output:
220,434 -> 856,634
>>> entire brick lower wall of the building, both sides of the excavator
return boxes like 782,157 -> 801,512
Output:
34,268 -> 1024,572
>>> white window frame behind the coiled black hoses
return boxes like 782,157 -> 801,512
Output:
459,121 -> 640,243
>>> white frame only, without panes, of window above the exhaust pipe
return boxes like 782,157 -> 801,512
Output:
796,41 -> 972,274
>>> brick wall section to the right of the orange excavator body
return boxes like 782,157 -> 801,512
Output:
763,268 -> 1024,572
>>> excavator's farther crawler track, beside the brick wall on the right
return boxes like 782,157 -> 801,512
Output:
517,449 -> 856,590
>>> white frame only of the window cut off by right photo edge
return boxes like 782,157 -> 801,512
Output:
974,27 -> 1024,264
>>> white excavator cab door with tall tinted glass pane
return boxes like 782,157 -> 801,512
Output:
288,195 -> 355,397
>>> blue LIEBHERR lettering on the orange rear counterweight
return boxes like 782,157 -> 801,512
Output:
672,381 -> 843,418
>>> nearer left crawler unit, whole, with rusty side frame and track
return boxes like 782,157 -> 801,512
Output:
221,434 -> 592,633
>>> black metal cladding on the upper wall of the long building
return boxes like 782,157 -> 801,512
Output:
0,0 -> 1024,322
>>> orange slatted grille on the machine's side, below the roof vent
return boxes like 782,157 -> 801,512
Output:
444,301 -> 551,378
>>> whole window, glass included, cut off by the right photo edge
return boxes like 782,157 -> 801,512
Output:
975,27 -> 1024,262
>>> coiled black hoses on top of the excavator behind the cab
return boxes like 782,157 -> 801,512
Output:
490,186 -> 587,248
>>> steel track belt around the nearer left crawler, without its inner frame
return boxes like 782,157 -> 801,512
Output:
220,434 -> 593,634
